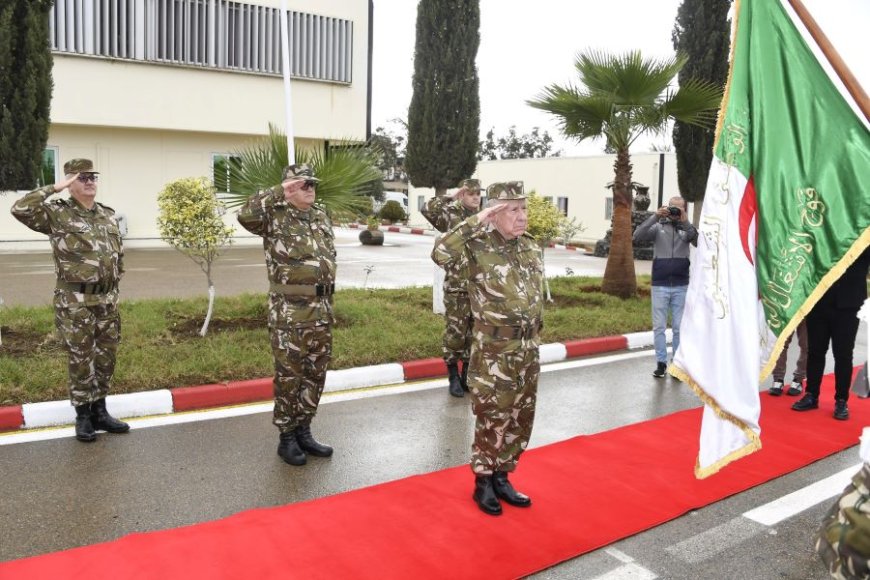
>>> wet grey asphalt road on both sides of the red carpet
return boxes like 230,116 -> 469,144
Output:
0,340 -> 858,579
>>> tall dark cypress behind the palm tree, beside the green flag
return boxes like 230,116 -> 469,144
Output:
671,0 -> 731,201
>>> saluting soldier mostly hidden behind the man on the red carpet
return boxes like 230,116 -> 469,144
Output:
422,179 -> 480,397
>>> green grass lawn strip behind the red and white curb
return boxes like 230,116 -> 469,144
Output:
0,276 -> 650,405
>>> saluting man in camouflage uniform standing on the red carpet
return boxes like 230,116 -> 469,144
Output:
432,181 -> 544,515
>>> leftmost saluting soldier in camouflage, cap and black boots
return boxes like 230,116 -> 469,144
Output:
12,159 -> 130,441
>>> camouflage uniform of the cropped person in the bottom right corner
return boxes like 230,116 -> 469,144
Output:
816,463 -> 870,579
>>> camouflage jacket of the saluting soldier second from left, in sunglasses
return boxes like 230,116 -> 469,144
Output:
238,187 -> 336,328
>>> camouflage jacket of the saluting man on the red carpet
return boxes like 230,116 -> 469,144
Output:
432,215 -> 544,327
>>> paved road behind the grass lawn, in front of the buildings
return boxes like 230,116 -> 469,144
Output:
0,228 -> 650,306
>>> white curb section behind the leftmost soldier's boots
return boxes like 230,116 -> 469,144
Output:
21,389 -> 172,429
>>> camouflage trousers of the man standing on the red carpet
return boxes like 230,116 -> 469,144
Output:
468,332 -> 541,474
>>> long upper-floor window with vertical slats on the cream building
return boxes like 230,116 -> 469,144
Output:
49,0 -> 353,83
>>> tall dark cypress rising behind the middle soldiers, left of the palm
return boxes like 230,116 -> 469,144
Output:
405,0 -> 480,195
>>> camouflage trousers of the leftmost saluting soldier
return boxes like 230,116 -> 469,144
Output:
54,302 -> 121,406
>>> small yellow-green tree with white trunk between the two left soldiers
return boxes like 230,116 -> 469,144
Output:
157,177 -> 233,336
